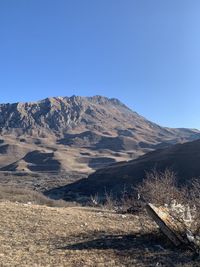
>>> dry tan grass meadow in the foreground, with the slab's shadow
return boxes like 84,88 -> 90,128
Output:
0,202 -> 198,267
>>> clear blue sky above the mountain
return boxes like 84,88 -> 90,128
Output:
0,0 -> 200,128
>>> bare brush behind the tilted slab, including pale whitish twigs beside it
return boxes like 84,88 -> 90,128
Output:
137,170 -> 200,246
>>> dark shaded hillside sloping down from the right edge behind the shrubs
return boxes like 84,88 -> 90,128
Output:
46,140 -> 200,199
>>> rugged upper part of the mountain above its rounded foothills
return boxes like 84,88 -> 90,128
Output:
0,96 -> 198,141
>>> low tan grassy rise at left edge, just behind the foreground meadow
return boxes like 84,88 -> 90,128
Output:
0,186 -> 67,207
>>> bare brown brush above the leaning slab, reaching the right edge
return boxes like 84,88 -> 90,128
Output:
137,170 -> 200,220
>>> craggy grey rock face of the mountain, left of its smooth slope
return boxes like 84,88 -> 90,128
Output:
0,95 -> 134,134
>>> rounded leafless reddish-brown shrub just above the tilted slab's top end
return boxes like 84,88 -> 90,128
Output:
137,169 -> 188,205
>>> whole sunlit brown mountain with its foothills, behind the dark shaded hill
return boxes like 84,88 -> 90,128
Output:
0,96 -> 200,173
